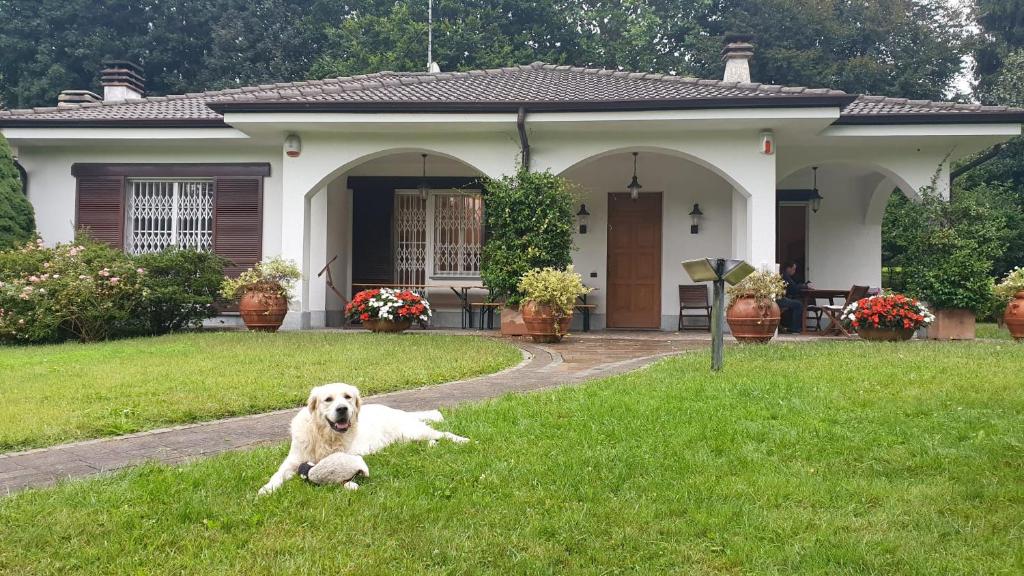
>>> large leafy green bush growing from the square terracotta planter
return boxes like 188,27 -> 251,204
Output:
885,182 -> 1009,314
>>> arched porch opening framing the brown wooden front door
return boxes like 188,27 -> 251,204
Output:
561,147 -> 745,330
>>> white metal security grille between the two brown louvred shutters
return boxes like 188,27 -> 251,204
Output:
125,179 -> 214,254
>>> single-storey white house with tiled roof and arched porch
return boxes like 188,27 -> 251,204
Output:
0,51 -> 1024,329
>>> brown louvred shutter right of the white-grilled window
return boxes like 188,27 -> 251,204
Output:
213,177 -> 263,277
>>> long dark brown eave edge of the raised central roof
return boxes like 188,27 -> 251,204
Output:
207,94 -> 856,114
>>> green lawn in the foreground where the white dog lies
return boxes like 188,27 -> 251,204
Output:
0,341 -> 1024,576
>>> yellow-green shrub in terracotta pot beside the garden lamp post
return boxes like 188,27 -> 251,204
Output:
725,271 -> 785,342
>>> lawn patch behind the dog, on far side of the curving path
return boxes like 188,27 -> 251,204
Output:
0,332 -> 522,451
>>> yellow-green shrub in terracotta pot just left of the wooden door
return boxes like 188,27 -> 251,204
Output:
518,265 -> 591,343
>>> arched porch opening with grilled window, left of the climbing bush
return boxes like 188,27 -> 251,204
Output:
307,150 -> 483,326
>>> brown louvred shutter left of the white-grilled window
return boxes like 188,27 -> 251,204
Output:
75,176 -> 125,248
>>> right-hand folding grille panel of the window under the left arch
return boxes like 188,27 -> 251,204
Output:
433,194 -> 483,277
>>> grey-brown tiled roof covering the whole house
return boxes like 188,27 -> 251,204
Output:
0,63 -> 1024,126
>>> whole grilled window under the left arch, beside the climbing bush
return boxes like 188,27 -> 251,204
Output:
393,191 -> 483,285
